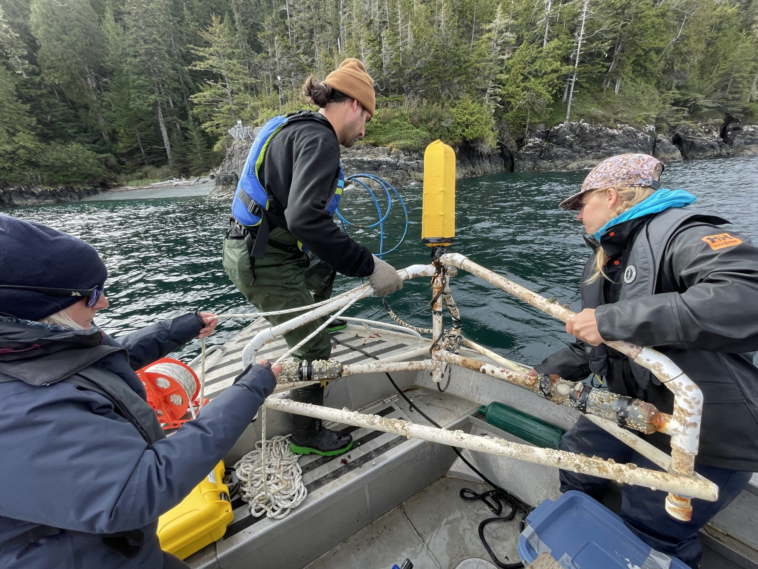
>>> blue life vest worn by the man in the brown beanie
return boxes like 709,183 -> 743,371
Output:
232,111 -> 345,258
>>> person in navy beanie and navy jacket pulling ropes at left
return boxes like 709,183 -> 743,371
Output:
0,215 -> 281,569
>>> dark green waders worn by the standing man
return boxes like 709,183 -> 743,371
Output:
223,227 -> 352,455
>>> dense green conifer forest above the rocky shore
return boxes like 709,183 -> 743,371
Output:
0,0 -> 758,186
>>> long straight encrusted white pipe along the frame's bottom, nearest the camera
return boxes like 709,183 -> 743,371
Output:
265,397 -> 718,502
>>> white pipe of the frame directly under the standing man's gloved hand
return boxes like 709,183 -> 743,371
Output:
242,265 -> 436,369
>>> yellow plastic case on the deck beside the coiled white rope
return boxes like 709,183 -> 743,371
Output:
158,462 -> 234,559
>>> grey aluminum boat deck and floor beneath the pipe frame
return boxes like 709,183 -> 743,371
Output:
187,319 -> 758,569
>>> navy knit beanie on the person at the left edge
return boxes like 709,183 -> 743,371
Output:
0,215 -> 108,320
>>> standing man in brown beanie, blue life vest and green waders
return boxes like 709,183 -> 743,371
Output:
224,59 -> 402,456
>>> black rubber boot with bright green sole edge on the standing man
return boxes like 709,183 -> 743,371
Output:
290,385 -> 353,456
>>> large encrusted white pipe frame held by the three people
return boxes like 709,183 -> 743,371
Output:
243,255 -> 719,521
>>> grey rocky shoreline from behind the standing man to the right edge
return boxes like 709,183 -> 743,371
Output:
211,119 -> 758,199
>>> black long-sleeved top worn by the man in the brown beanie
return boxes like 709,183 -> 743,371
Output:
258,116 -> 374,277
